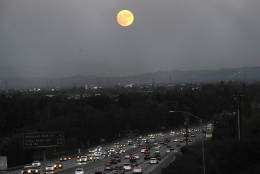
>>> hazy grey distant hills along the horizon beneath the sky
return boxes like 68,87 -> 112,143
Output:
0,67 -> 260,89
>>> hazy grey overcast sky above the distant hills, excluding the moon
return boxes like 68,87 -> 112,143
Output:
0,0 -> 260,77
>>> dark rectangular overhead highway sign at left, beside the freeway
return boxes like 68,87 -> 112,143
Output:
23,132 -> 64,148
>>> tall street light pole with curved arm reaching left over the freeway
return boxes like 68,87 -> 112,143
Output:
169,111 -> 206,174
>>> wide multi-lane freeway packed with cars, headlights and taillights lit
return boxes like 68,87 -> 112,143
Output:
13,128 -> 201,174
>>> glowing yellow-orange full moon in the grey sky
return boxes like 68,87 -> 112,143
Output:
117,10 -> 134,27
